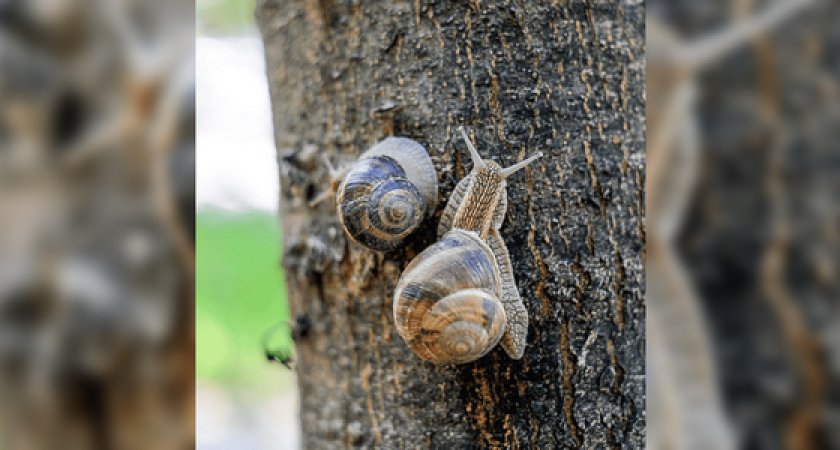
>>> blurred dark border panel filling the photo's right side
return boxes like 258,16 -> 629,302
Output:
646,0 -> 840,450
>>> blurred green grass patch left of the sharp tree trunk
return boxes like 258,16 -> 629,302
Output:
196,208 -> 291,393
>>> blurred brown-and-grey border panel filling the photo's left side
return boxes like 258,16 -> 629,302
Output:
0,0 -> 195,450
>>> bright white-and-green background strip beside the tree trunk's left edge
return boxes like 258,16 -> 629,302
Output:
196,0 -> 299,450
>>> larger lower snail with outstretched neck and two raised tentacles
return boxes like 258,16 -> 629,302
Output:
394,127 -> 542,364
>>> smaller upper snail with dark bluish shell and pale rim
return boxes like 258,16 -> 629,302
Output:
310,137 -> 437,251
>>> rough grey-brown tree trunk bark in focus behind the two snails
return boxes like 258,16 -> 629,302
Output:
257,0 -> 645,449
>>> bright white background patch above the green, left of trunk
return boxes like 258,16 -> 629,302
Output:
196,38 -> 279,212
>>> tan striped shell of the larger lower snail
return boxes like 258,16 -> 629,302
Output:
394,229 -> 506,364
